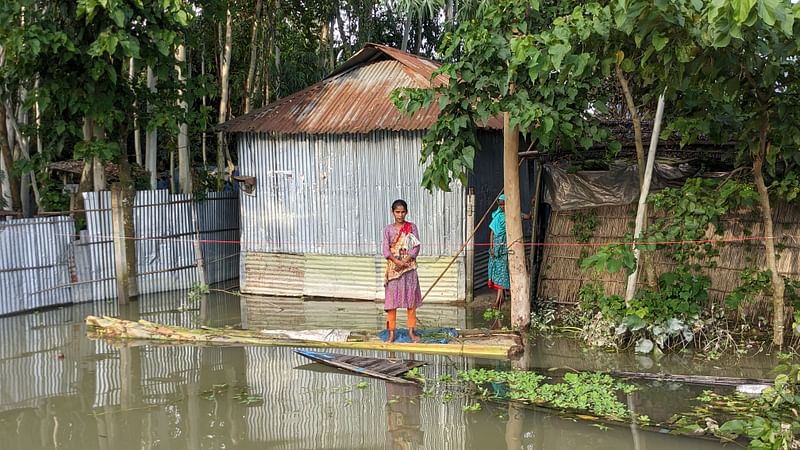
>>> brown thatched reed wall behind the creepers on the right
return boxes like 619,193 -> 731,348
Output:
539,204 -> 800,312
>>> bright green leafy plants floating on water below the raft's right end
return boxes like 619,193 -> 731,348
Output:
459,369 -> 635,420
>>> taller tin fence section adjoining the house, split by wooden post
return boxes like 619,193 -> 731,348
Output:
75,190 -> 239,301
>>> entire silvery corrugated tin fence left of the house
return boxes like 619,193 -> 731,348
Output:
0,190 -> 239,316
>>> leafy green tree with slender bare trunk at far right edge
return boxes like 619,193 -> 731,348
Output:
673,0 -> 800,346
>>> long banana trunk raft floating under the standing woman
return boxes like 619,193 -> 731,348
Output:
86,316 -> 524,359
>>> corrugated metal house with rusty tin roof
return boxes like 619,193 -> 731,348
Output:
223,44 -> 527,302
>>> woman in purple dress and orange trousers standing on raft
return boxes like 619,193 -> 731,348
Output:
383,200 -> 422,342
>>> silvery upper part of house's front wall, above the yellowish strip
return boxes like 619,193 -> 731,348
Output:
238,131 -> 465,256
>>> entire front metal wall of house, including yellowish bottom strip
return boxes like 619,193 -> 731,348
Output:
238,131 -> 465,301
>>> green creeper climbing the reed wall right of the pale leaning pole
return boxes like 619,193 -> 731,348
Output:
580,178 -> 768,353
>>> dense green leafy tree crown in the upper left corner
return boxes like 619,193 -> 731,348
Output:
0,0 -> 191,199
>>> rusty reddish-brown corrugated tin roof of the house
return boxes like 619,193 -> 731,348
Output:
219,44 -> 502,134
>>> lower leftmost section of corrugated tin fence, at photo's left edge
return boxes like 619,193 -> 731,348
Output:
0,217 -> 75,315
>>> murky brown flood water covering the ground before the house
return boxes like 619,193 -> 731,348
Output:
0,293 -> 769,450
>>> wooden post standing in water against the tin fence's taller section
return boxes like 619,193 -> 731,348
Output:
111,183 -> 139,305
